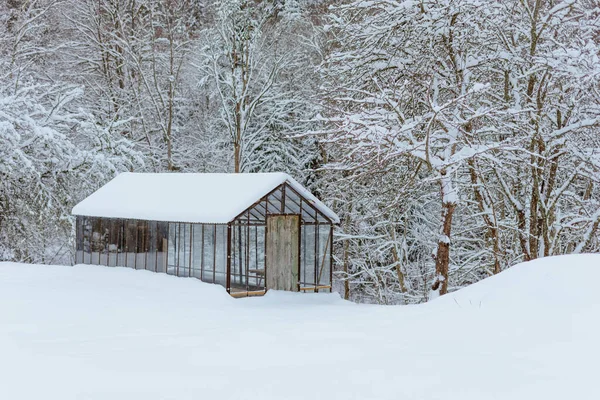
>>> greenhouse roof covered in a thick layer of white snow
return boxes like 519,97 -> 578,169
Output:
72,172 -> 339,224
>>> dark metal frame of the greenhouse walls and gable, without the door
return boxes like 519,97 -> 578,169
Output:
75,182 -> 334,297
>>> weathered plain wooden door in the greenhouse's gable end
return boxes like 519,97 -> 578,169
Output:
266,215 -> 300,292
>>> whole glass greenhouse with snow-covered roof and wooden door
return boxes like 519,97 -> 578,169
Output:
73,173 -> 339,297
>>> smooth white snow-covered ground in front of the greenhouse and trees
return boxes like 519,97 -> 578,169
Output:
0,255 -> 600,400
